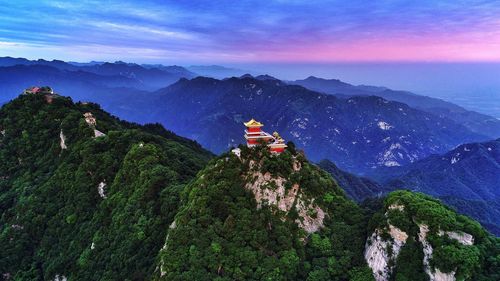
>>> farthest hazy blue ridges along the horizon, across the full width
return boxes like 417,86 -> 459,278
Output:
0,57 -> 500,142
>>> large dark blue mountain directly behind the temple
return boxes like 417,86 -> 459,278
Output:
148,77 -> 485,173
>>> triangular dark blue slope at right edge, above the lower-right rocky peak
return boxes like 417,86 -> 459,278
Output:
379,139 -> 500,235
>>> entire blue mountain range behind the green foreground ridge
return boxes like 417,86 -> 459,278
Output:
0,58 -> 500,233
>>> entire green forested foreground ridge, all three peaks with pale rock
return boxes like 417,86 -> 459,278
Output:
0,84 -> 500,281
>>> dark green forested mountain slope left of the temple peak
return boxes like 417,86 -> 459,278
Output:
0,91 -> 211,280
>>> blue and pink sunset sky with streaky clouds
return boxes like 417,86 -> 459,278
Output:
0,0 -> 500,64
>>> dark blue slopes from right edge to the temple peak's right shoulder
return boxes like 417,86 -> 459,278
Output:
318,137 -> 500,236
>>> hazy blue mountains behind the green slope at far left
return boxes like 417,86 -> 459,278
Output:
0,65 -> 160,122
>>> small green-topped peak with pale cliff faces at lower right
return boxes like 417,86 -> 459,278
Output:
365,191 -> 492,281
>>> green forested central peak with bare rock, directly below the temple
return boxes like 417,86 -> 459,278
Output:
157,144 -> 371,280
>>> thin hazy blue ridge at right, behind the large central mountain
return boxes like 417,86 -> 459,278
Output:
289,76 -> 500,138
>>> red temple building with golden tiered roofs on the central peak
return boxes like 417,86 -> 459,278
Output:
243,119 -> 287,153
